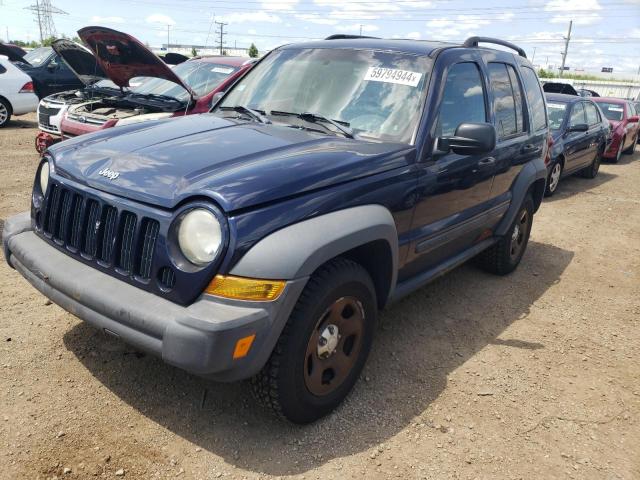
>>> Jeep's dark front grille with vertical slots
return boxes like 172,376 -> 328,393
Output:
40,183 -> 160,280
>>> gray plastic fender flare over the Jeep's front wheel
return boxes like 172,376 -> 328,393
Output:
230,205 -> 398,302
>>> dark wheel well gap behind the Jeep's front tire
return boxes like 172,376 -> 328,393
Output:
340,240 -> 393,308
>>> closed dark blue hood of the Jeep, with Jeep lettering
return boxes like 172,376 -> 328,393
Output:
49,114 -> 413,212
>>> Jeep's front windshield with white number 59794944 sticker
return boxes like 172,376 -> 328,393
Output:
216,48 -> 432,143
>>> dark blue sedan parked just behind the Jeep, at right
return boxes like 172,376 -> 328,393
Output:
545,93 -> 611,196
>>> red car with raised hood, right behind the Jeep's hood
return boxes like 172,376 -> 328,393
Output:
60,27 -> 253,138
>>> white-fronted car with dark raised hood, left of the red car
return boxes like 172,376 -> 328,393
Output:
36,39 -> 126,153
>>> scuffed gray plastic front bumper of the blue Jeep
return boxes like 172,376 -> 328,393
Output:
3,213 -> 307,381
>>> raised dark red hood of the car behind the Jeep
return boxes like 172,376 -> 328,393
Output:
78,27 -> 196,98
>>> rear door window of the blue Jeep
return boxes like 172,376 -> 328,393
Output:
489,63 -> 524,140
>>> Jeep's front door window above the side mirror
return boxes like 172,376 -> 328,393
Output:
436,62 -> 487,137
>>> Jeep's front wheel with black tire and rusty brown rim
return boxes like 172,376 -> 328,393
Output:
251,258 -> 378,424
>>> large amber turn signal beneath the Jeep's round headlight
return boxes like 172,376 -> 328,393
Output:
204,275 -> 286,302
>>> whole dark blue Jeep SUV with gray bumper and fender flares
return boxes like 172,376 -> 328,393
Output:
3,35 -> 548,423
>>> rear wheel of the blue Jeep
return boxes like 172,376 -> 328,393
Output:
476,195 -> 534,275
